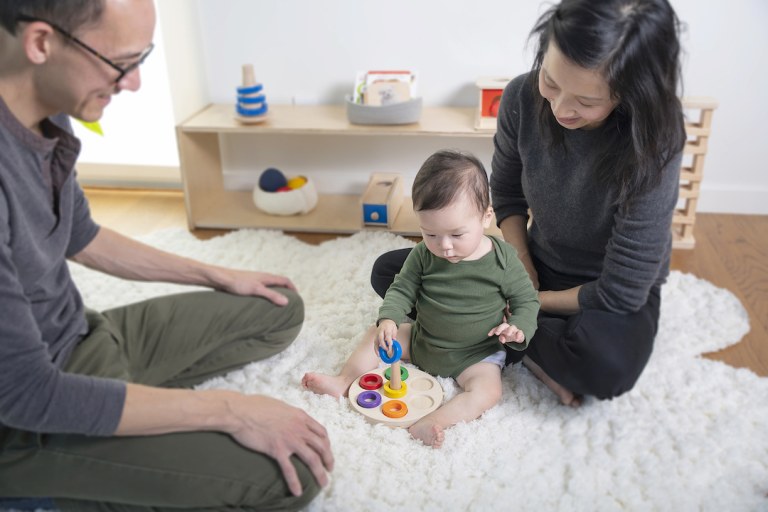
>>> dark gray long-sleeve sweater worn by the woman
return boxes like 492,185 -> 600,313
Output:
490,74 -> 682,313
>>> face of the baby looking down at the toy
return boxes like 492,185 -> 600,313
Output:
416,194 -> 493,263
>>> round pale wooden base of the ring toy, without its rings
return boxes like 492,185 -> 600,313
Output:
349,366 -> 443,427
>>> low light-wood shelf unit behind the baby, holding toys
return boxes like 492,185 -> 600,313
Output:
176,98 -> 717,248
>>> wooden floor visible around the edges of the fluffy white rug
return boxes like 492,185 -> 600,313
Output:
86,188 -> 768,376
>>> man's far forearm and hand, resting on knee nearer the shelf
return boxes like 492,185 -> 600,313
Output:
72,227 -> 296,306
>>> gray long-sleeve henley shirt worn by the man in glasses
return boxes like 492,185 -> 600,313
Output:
0,98 -> 125,435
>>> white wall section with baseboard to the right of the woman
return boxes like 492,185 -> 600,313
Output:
672,0 -> 768,214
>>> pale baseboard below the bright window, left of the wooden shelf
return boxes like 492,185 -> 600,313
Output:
77,163 -> 181,189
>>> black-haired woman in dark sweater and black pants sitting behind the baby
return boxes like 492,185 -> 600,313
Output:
371,0 -> 685,406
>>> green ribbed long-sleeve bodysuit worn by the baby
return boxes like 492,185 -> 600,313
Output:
379,237 -> 539,378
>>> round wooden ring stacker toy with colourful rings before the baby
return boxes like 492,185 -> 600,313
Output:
348,340 -> 443,427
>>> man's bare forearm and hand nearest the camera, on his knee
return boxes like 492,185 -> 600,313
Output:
115,383 -> 334,496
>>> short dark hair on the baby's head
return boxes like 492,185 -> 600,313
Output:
411,150 -> 491,214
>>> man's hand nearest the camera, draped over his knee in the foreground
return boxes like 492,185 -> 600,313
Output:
230,395 -> 333,496
